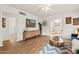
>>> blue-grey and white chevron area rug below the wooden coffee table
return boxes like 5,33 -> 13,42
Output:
39,44 -> 70,54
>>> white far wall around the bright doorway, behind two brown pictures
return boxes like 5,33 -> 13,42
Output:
43,11 -> 79,38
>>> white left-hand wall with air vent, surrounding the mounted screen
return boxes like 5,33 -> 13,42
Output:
0,5 -> 39,45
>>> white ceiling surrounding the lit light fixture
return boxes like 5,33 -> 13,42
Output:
9,4 -> 79,17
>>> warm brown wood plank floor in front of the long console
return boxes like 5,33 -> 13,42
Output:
0,36 -> 49,54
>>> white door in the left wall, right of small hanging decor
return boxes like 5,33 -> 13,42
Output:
8,17 -> 17,39
